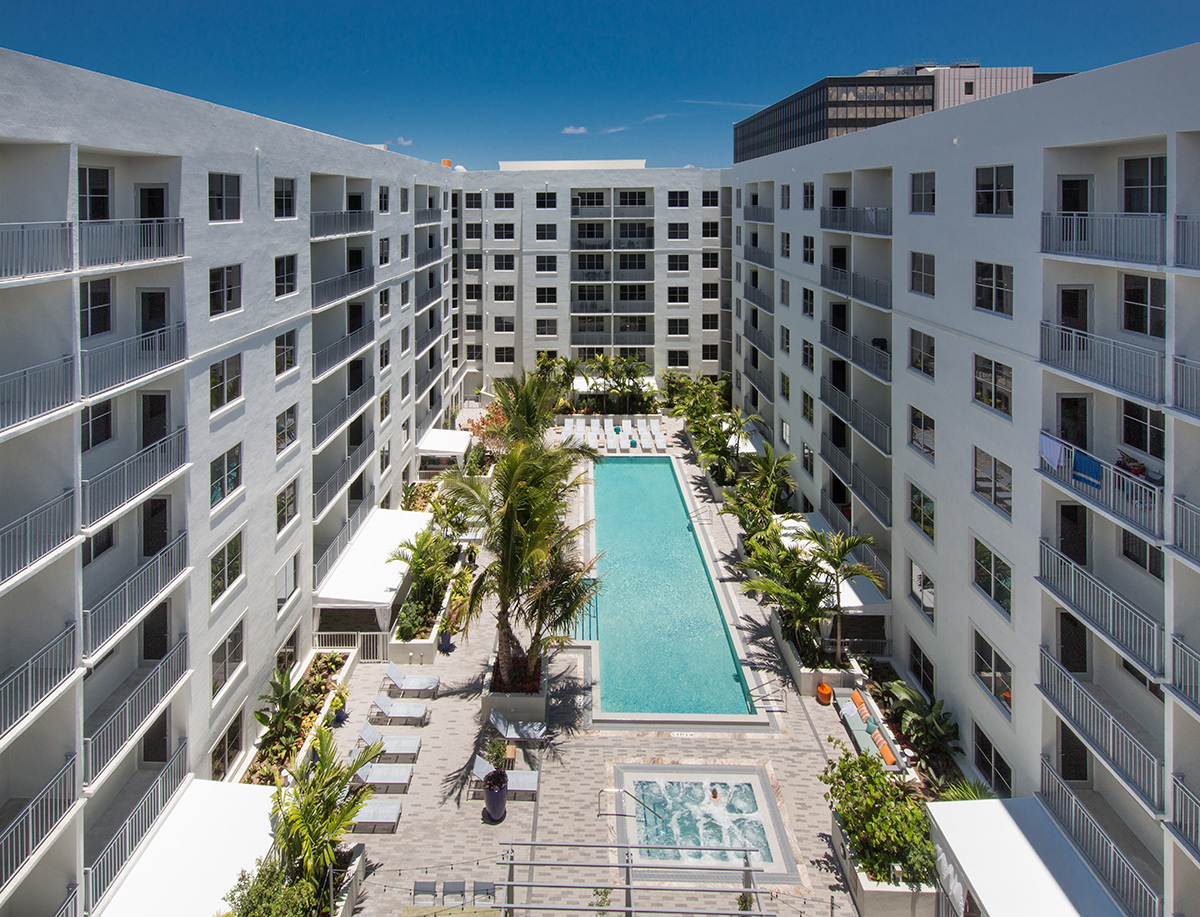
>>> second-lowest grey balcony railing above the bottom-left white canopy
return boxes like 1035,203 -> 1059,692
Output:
83,634 -> 187,784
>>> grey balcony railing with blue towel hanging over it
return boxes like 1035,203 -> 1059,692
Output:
1038,430 -> 1163,538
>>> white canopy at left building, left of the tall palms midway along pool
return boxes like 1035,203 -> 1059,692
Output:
312,509 -> 433,628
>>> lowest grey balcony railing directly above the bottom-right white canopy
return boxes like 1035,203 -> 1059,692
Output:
1039,755 -> 1163,917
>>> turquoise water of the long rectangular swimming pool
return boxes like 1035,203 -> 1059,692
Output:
593,457 -> 754,714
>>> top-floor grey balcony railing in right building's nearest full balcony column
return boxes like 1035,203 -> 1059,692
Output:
1042,212 -> 1166,264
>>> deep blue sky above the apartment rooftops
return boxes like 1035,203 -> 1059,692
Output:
0,0 -> 1200,169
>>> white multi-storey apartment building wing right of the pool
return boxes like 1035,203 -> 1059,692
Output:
732,46 -> 1200,917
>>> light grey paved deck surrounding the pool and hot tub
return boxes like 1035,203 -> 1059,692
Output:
336,419 -> 856,917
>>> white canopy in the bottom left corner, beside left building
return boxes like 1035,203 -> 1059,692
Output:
104,780 -> 275,917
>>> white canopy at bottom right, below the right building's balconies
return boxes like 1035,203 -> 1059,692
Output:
929,799 -> 1122,917
